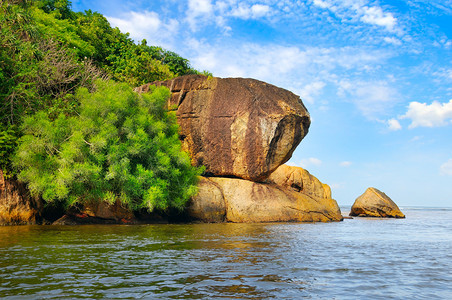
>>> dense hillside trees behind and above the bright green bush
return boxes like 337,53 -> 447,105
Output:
0,0 -> 208,176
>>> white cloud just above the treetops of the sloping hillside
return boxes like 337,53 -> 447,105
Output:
107,11 -> 179,47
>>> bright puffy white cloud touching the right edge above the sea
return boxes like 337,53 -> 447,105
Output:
400,99 -> 452,128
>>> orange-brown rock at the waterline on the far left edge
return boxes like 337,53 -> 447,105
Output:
0,170 -> 42,225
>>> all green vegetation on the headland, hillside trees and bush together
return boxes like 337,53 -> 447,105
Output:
0,0 -> 206,210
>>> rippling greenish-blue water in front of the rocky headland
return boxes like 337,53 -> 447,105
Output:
0,208 -> 452,299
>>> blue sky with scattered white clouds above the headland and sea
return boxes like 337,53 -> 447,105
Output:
72,0 -> 452,208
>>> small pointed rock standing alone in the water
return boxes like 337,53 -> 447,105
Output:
350,187 -> 405,218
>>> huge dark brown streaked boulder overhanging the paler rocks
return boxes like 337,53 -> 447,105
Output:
136,75 -> 310,182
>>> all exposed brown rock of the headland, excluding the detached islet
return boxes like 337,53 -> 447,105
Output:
0,75 -> 342,224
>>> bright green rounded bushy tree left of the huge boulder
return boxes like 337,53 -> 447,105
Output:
14,81 -> 203,211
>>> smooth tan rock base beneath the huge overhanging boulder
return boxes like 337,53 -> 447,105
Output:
188,166 -> 342,223
